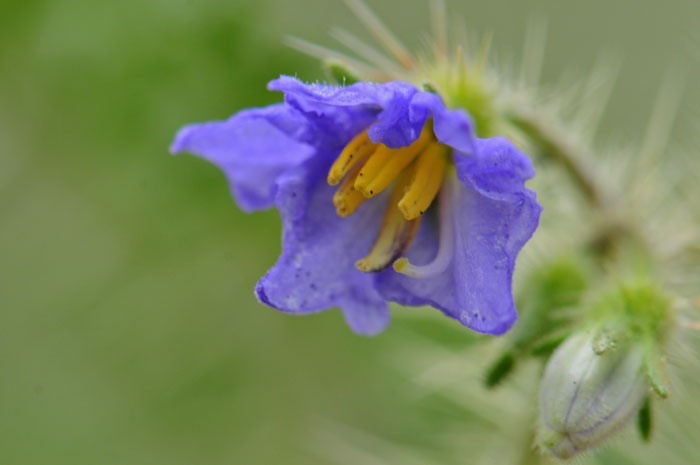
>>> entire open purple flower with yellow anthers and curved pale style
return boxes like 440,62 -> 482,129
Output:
171,77 -> 541,334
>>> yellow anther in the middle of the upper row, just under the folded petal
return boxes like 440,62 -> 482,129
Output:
355,125 -> 433,198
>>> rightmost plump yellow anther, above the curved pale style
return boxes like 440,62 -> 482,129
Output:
399,143 -> 447,220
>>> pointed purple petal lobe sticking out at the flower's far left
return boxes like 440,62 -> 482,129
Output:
170,105 -> 315,212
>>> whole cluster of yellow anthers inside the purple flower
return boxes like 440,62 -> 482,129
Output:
328,124 -> 449,272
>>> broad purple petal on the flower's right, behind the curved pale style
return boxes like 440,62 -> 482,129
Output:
377,141 -> 542,334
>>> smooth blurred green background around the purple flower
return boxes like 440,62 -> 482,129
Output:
0,0 -> 700,465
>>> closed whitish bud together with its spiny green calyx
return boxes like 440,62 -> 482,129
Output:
539,283 -> 674,459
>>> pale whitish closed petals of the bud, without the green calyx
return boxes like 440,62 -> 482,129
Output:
539,332 -> 648,459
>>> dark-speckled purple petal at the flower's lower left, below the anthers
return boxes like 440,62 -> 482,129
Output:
256,160 -> 389,334
